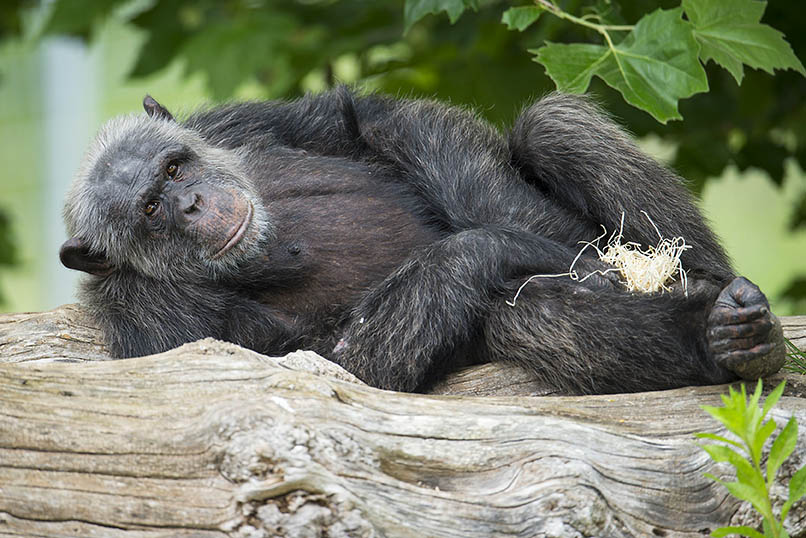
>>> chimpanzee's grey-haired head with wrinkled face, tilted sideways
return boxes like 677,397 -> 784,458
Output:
61,116 -> 271,278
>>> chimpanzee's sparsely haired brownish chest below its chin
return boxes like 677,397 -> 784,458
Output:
261,160 -> 439,317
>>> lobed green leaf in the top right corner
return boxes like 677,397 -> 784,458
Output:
683,0 -> 806,84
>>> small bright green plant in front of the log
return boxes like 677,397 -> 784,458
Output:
697,379 -> 806,538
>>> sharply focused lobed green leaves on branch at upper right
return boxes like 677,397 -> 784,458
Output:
404,0 -> 806,123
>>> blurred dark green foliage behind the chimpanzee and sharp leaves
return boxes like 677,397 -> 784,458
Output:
0,0 -> 806,310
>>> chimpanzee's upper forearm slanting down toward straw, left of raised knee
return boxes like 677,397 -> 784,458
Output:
356,94 -> 599,241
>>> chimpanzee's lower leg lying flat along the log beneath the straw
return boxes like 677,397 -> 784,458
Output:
480,279 -> 783,394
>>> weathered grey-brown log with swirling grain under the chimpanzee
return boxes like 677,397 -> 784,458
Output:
0,307 -> 806,537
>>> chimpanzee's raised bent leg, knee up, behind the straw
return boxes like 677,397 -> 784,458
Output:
509,94 -> 734,278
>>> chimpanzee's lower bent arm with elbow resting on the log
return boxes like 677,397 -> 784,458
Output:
331,226 -> 614,391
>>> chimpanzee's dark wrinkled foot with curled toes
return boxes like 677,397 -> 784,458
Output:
707,277 -> 786,379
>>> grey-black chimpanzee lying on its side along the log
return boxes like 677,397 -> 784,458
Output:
60,87 -> 783,393
